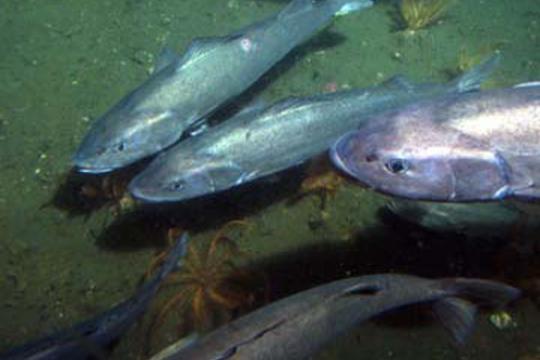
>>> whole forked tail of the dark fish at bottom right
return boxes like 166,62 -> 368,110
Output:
433,278 -> 521,345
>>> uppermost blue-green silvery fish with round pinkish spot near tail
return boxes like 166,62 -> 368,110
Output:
73,0 -> 373,174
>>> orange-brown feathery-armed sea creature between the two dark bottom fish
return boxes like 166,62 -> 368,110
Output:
143,220 -> 260,349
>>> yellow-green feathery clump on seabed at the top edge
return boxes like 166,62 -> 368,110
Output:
399,0 -> 454,32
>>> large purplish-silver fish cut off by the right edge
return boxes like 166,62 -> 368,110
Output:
330,84 -> 540,202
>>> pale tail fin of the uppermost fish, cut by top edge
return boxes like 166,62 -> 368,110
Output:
279,0 -> 373,18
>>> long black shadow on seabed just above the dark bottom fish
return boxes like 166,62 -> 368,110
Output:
242,212 -> 540,326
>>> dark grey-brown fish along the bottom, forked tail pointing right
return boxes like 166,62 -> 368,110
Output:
147,274 -> 520,360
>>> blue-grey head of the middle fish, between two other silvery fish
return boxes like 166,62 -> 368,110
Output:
129,150 -> 244,203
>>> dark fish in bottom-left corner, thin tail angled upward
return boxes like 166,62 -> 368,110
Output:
0,233 -> 188,360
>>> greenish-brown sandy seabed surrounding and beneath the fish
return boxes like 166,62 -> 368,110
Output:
0,0 -> 540,360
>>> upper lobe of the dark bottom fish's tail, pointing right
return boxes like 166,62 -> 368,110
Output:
443,278 -> 521,307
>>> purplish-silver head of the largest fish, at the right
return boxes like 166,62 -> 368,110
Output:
331,111 -> 509,201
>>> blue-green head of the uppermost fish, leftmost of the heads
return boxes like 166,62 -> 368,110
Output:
73,108 -> 181,174
